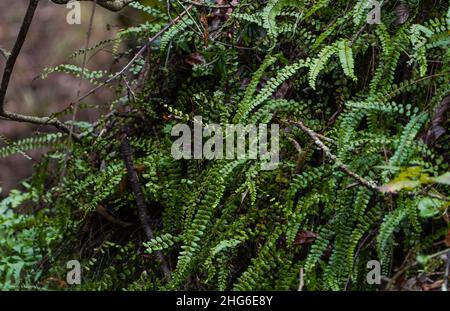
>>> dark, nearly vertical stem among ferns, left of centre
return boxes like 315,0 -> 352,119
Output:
120,126 -> 170,277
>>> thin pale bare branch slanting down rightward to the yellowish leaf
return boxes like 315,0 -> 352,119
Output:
287,120 -> 449,201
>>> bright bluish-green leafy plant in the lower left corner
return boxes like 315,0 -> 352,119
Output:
0,188 -> 63,290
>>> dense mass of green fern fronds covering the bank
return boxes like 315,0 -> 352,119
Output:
0,0 -> 450,290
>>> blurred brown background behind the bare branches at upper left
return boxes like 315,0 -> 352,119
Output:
0,0 -> 133,197
